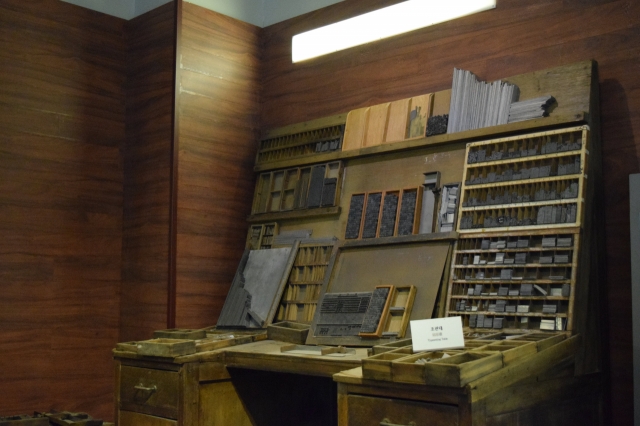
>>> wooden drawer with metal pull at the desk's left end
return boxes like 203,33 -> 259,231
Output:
120,365 -> 180,424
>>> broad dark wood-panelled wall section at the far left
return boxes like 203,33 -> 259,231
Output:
0,0 -> 125,419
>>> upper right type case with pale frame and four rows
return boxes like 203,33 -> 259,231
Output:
458,126 -> 589,233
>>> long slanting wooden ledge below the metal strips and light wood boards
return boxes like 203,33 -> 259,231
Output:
254,112 -> 588,172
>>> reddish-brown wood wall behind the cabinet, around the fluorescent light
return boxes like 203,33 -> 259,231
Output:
261,0 -> 640,425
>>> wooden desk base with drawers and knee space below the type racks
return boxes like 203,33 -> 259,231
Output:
114,338 -> 600,426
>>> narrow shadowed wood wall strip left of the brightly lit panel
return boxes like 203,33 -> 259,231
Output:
120,2 -> 175,341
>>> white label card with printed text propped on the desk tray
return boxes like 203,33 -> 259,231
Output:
410,317 -> 464,352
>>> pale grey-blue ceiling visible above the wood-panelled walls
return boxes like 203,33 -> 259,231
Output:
61,0 -> 344,27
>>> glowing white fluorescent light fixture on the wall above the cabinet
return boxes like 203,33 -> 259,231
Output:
291,0 -> 496,62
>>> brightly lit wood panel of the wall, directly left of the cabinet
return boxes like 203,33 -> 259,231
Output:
176,3 -> 260,328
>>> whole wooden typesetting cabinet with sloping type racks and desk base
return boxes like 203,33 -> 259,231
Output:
114,61 -> 602,426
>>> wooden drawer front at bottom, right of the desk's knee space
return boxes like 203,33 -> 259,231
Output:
348,395 -> 458,426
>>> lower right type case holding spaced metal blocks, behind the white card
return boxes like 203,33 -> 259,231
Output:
447,228 -> 580,331
